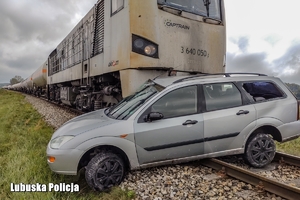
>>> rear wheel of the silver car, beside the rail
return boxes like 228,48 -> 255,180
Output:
244,133 -> 276,168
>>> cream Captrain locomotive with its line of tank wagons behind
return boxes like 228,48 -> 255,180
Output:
9,0 -> 226,110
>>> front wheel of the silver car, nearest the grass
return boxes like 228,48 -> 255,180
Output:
85,152 -> 125,191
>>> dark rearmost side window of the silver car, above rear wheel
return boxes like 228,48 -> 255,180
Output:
243,81 -> 284,102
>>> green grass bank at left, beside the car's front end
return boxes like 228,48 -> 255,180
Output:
0,89 -> 135,200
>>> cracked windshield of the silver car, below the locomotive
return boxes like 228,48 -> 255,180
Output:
106,80 -> 164,120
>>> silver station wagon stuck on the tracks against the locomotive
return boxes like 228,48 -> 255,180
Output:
47,73 -> 300,191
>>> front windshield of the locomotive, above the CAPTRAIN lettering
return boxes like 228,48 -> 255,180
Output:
157,0 -> 221,20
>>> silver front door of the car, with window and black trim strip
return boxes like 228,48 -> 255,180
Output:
134,85 -> 204,164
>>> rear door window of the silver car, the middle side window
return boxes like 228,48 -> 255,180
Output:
203,83 -> 242,111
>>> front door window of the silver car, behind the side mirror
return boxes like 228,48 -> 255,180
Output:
150,85 -> 197,119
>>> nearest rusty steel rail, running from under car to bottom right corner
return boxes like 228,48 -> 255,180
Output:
200,158 -> 300,200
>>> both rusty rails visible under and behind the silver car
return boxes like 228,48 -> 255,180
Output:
201,152 -> 300,200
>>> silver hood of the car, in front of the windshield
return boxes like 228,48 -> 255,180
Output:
52,109 -> 121,138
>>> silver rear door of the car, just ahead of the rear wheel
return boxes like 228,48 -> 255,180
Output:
203,83 -> 256,154
